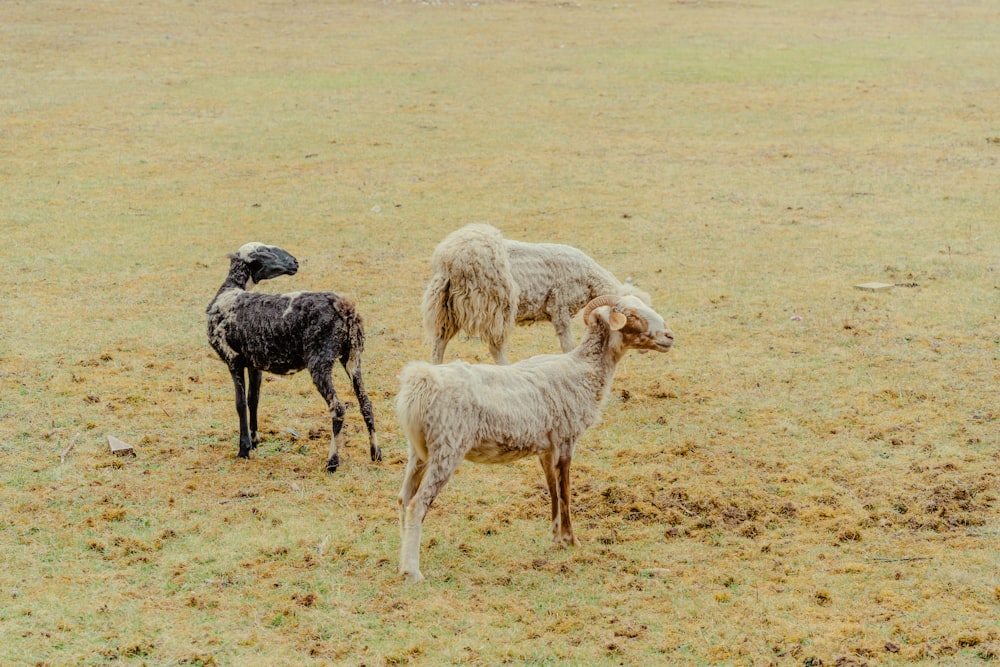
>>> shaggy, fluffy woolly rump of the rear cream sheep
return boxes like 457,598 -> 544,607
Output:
422,223 -> 518,347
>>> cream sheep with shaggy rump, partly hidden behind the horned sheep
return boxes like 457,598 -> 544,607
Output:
421,223 -> 652,365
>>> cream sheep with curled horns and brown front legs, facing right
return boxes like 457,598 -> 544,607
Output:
396,295 -> 674,581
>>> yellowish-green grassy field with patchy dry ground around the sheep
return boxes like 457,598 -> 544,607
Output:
0,0 -> 1000,667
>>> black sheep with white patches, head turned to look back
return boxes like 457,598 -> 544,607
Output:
206,242 -> 382,472
